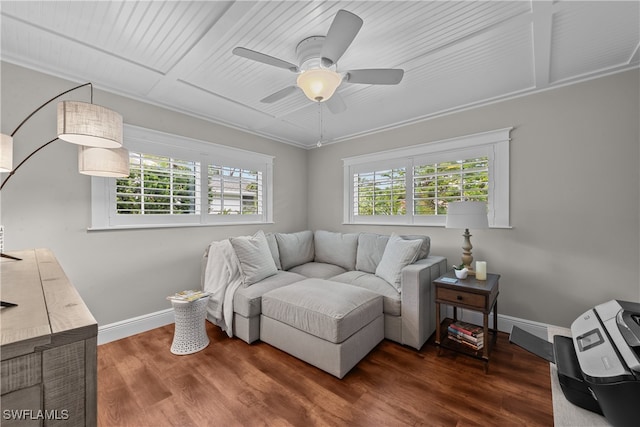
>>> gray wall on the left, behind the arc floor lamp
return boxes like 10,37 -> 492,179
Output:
0,62 -> 307,325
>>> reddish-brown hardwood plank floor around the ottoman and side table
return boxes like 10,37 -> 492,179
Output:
98,322 -> 553,427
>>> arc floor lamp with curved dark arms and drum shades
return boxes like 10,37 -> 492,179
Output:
0,83 -> 129,306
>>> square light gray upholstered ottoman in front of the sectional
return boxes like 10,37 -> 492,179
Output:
260,279 -> 384,378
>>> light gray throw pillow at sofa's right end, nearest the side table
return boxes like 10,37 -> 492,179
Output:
376,233 -> 422,292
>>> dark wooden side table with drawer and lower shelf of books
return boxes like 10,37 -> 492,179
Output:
433,271 -> 500,373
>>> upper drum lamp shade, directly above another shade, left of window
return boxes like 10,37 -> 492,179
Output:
58,101 -> 122,148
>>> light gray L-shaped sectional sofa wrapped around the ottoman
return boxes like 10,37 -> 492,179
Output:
203,230 -> 447,349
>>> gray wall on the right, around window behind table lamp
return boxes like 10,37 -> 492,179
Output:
308,70 -> 640,326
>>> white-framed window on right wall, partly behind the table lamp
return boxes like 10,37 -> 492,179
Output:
344,128 -> 511,227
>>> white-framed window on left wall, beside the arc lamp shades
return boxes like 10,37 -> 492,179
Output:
91,125 -> 273,229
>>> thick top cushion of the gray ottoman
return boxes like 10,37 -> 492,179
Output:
262,279 -> 382,343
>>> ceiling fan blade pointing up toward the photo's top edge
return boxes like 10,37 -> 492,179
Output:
320,9 -> 363,67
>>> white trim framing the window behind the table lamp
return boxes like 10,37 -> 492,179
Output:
342,127 -> 513,228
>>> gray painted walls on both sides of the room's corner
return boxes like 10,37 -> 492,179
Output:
0,63 -> 640,326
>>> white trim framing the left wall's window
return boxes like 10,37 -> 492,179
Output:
89,124 -> 274,230
